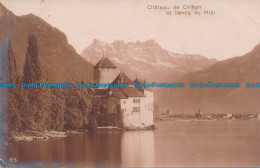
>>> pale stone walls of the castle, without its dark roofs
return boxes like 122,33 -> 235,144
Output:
94,57 -> 153,129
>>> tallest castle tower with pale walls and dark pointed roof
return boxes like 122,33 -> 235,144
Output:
94,57 -> 120,83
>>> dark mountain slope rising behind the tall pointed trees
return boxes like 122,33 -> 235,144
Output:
0,3 -> 93,82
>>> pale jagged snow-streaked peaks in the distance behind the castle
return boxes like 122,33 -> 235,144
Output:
81,39 -> 216,82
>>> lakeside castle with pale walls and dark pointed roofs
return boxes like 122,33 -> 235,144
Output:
94,57 -> 153,129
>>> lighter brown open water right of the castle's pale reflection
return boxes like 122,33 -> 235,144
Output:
155,120 -> 260,167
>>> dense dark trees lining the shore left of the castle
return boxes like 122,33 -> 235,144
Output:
8,35 -> 122,133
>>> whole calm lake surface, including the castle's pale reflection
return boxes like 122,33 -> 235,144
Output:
8,120 -> 260,167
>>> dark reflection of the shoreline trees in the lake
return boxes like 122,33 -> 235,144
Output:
8,131 -> 122,167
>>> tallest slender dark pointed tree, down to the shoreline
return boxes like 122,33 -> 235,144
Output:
20,35 -> 47,131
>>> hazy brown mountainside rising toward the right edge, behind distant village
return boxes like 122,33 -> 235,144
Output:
155,44 -> 260,114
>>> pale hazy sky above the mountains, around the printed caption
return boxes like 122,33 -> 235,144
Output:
0,0 -> 260,60
